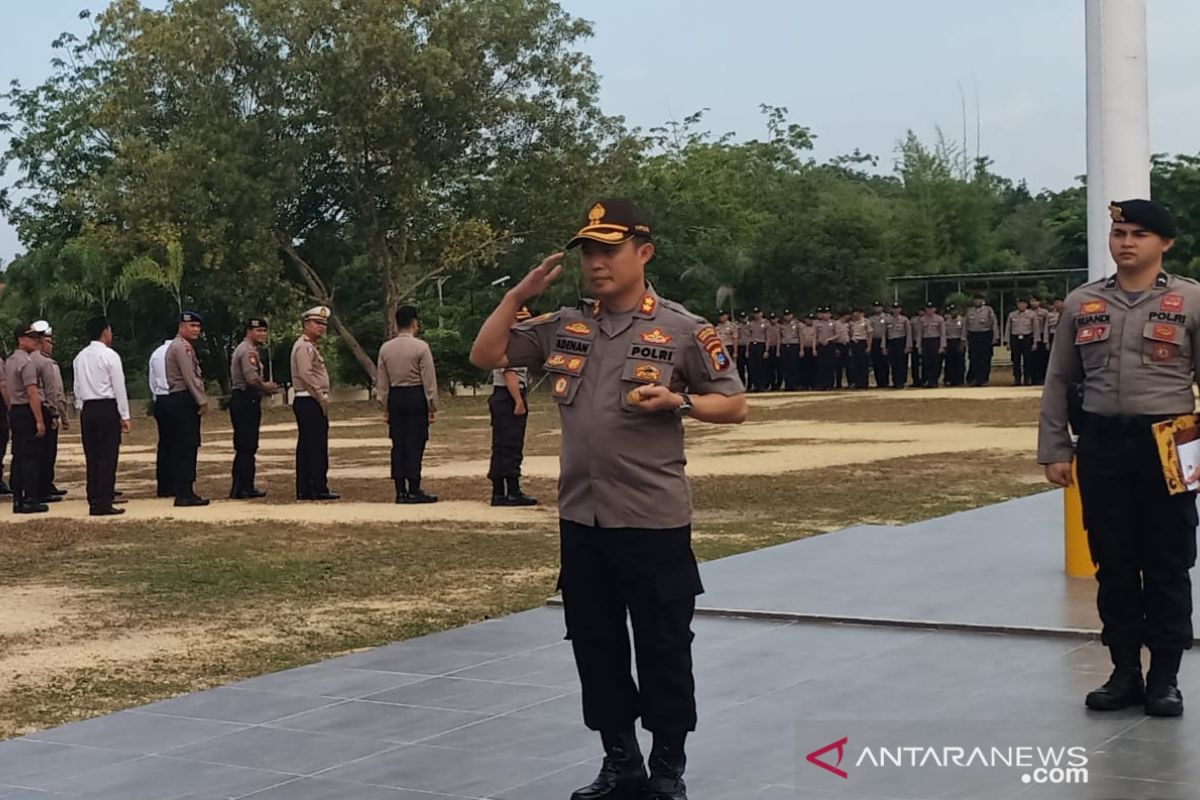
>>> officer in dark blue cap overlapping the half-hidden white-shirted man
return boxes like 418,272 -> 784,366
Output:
167,311 -> 209,506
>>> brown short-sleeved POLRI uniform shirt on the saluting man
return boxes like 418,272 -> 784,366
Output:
508,287 -> 745,529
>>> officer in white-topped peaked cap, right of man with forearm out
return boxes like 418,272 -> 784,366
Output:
290,306 -> 342,500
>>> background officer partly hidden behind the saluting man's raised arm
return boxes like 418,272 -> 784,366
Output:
487,306 -> 535,506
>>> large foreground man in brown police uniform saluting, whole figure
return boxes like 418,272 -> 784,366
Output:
472,199 -> 746,800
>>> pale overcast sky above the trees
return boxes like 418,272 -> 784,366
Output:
0,0 -> 1200,261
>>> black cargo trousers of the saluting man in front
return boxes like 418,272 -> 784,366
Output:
559,519 -> 703,733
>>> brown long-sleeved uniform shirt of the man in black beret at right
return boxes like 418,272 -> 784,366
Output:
1038,272 -> 1200,464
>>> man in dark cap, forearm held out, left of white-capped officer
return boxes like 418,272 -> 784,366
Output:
229,317 -> 280,500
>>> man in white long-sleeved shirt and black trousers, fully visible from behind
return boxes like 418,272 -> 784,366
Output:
74,317 -> 130,517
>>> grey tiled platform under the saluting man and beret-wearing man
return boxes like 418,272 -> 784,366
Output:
0,493 -> 1200,800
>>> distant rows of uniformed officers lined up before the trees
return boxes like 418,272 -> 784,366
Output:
716,295 -> 1012,392
